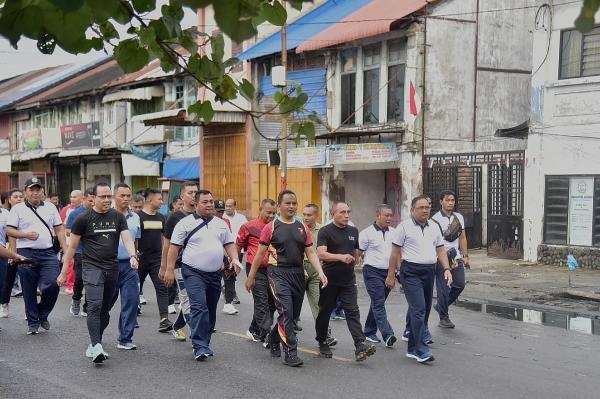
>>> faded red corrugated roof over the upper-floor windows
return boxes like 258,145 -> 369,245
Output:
296,0 -> 428,53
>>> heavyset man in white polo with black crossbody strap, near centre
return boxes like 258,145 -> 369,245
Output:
164,190 -> 241,361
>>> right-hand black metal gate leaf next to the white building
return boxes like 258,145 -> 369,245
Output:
487,163 -> 524,259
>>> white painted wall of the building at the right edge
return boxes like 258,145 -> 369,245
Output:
524,1 -> 600,261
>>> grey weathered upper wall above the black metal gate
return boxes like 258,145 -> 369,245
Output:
425,0 -> 535,154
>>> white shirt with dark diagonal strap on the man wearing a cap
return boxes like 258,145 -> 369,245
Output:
8,201 -> 62,249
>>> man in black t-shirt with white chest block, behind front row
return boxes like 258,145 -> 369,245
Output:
137,188 -> 173,332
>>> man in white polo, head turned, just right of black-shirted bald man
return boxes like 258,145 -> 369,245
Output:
358,204 -> 397,348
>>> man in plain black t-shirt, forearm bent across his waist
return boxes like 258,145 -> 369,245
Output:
315,202 -> 376,362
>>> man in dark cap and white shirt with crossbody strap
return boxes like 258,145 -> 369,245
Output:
6,177 -> 67,334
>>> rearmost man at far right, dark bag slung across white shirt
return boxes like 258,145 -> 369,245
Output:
431,190 -> 470,328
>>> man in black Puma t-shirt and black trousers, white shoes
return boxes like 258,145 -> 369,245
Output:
56,183 -> 138,363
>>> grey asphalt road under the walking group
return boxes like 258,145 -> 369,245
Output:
0,277 -> 600,399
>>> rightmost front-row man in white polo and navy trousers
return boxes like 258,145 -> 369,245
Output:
385,195 -> 452,363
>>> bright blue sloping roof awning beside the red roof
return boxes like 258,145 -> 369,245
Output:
236,0 -> 371,61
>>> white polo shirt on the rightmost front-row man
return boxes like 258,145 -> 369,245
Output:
392,217 -> 444,265
